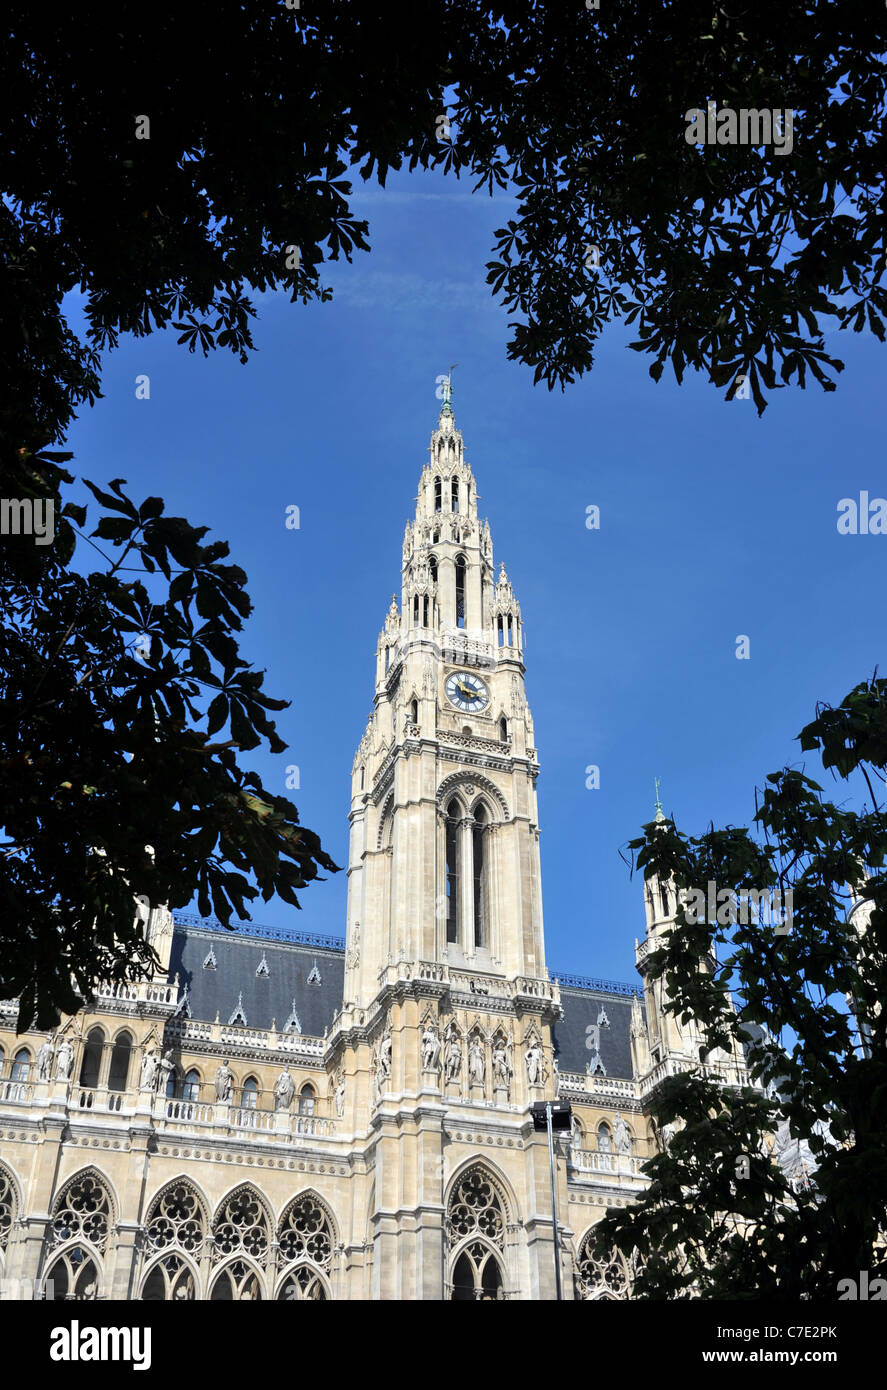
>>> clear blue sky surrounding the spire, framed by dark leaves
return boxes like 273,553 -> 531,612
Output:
70,165 -> 887,981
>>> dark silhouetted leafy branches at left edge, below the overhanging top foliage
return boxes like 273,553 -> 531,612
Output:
0,469 -> 336,1030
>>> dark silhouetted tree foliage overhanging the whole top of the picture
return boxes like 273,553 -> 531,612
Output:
0,0 -> 887,446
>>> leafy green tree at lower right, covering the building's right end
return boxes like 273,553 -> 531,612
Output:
596,677 -> 887,1301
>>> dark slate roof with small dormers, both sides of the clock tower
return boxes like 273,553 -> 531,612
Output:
170,919 -> 642,1080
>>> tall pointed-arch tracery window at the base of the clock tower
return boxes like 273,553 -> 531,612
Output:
446,1168 -> 505,1302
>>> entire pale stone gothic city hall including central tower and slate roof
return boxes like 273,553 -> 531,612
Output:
0,402 -> 742,1301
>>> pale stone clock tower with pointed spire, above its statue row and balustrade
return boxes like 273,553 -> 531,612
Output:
345,400 -> 545,1008
